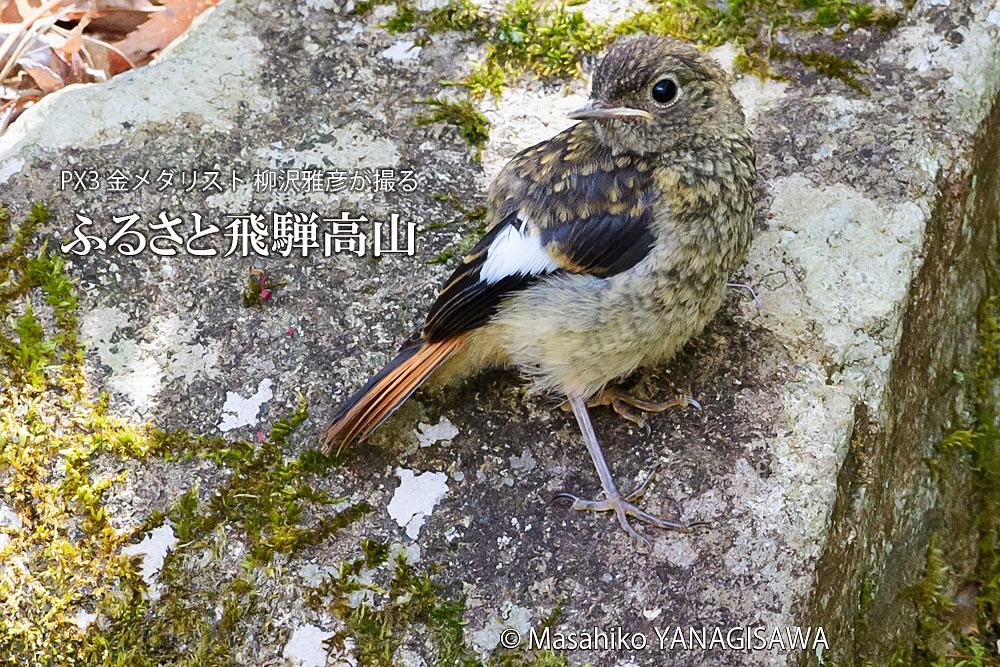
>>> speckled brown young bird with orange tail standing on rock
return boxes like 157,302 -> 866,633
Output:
322,36 -> 756,548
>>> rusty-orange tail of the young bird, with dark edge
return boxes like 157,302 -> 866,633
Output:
320,336 -> 465,454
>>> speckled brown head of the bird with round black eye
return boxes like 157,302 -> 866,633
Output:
569,36 -> 743,153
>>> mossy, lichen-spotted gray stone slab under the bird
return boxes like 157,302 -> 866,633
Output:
0,0 -> 1000,665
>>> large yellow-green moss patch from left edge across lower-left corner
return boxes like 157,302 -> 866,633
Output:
0,204 -> 369,665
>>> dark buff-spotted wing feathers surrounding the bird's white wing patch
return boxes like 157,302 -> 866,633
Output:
421,123 -> 656,342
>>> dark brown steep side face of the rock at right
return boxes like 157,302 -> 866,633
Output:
810,98 -> 1000,660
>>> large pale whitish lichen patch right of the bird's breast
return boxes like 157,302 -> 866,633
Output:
748,176 -> 923,414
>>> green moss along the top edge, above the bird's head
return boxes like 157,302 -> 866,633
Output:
396,0 -> 902,154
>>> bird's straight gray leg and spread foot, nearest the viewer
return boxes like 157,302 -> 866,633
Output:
556,397 -> 708,551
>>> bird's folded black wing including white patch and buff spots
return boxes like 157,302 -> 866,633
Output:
421,147 -> 655,342
